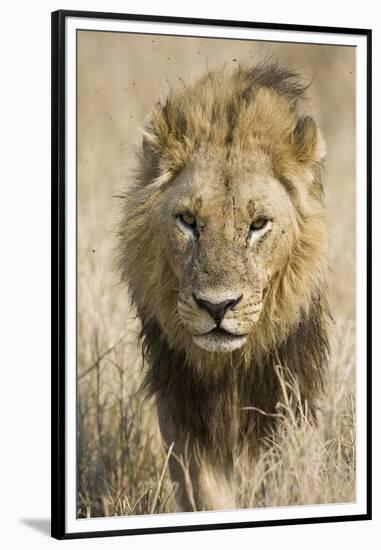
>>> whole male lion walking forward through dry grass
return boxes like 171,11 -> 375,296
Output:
119,63 -> 329,510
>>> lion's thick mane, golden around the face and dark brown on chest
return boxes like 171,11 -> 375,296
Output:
119,63 -> 329,460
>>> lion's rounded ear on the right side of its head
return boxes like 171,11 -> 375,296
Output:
292,116 -> 326,162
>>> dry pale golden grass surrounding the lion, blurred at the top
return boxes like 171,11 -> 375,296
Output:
77,31 -> 356,517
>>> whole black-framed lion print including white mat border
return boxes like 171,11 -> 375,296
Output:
52,11 -> 371,539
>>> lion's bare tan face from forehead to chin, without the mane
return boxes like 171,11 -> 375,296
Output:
160,148 -> 295,352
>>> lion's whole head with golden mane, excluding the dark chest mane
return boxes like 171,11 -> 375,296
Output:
119,65 -> 327,368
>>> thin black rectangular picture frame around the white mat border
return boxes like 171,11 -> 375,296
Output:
51,10 -> 372,539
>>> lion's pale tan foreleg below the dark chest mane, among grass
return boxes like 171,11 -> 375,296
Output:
157,400 -> 236,512
